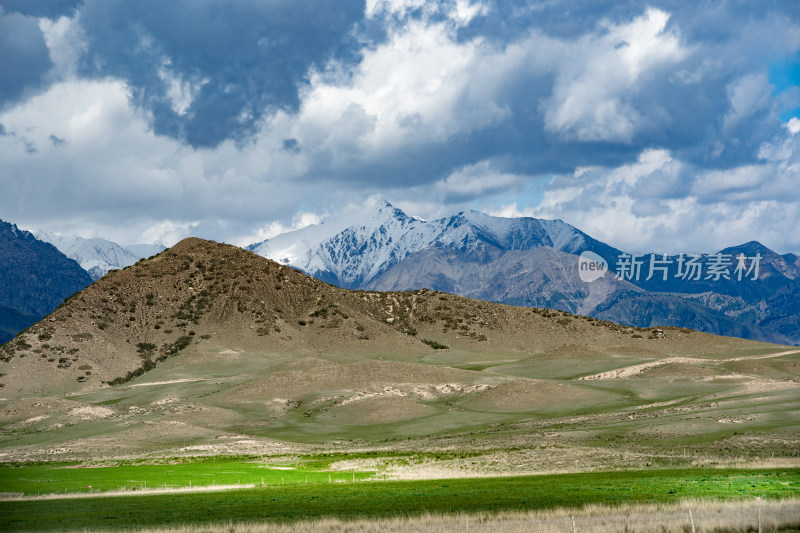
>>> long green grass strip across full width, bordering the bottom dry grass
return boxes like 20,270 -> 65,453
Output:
0,469 -> 800,531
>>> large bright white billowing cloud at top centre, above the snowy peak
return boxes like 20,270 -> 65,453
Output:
264,16 -> 509,168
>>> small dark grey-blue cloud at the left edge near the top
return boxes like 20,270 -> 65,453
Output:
0,7 -> 53,109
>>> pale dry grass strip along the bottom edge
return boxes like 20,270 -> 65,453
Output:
90,498 -> 800,533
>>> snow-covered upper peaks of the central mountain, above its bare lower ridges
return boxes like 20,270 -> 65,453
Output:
247,202 -> 616,288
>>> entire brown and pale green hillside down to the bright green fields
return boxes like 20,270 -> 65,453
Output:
0,239 -> 800,470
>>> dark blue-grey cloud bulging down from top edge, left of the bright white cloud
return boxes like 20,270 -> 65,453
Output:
75,0 -> 363,147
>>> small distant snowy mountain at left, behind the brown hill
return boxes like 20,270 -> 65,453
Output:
32,231 -> 164,281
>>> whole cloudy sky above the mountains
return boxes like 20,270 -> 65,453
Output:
0,0 -> 800,253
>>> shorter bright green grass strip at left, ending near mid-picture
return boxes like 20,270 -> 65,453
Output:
0,461 -> 372,495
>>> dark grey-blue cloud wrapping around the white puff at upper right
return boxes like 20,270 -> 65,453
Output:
459,0 -> 800,173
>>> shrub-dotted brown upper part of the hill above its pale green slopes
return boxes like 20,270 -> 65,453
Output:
0,238 -> 743,395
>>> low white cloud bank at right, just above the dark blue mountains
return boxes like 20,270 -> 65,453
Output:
532,139 -> 800,253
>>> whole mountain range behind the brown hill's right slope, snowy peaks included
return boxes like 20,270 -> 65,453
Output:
248,202 -> 800,344
